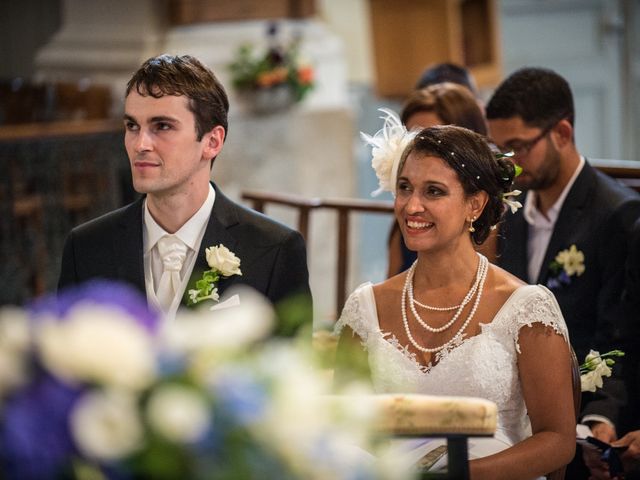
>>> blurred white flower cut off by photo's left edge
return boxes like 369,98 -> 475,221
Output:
0,307 -> 29,398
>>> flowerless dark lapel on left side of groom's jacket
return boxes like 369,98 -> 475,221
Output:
113,197 -> 146,296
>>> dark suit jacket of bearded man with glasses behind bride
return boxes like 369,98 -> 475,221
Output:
498,162 -> 640,423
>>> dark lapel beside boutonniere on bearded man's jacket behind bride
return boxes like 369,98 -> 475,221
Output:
537,162 -> 595,285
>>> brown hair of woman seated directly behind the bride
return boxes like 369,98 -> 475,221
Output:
400,82 -> 487,135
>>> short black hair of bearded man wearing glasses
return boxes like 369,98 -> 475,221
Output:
485,67 -> 575,128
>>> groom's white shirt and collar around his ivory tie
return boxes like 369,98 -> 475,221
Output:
142,184 -> 216,319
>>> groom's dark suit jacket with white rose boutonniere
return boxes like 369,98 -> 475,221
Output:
58,185 -> 311,333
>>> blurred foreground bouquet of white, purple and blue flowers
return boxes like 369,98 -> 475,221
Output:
0,282 -> 408,480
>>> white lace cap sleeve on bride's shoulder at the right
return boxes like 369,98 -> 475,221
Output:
509,285 -> 569,353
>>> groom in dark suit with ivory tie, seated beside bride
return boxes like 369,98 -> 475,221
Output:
58,55 -> 311,335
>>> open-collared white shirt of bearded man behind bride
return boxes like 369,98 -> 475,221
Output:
522,156 -> 585,283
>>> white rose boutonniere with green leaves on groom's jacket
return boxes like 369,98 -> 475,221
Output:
187,244 -> 242,307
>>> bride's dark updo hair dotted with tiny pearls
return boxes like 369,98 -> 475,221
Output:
398,125 -> 515,245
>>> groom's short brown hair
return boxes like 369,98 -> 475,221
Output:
126,54 -> 229,140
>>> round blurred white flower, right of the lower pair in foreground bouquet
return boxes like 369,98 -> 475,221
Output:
147,384 -> 211,443
